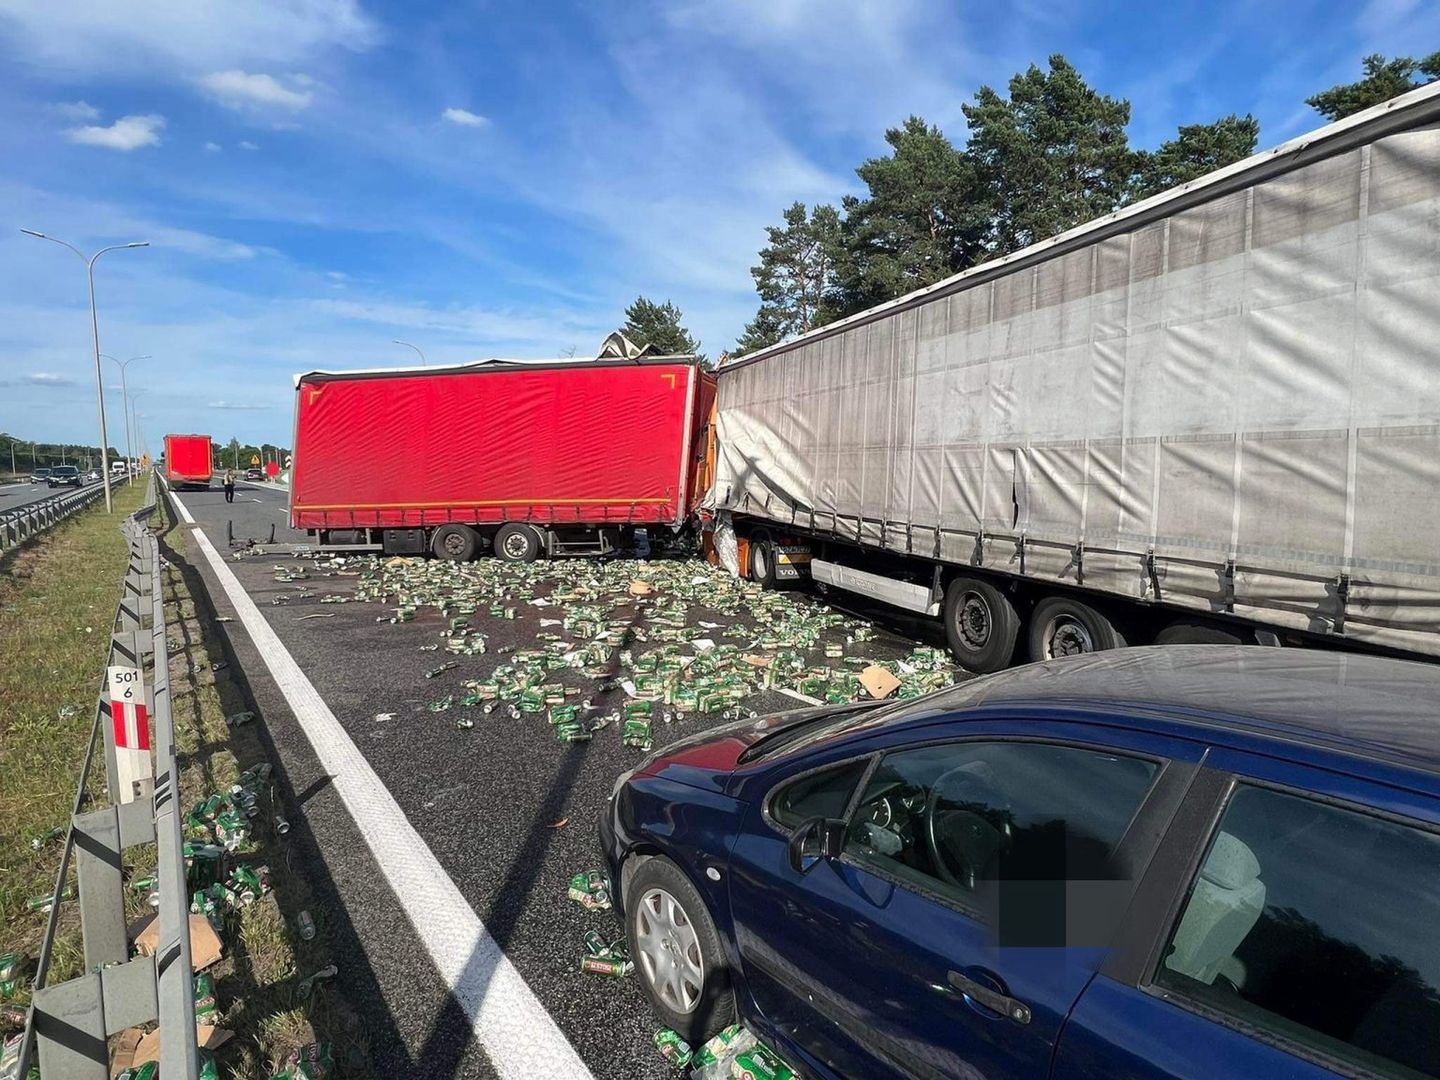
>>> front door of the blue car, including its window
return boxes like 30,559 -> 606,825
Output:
730,717 -> 1201,1077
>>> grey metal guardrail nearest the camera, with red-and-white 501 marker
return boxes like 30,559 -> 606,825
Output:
14,474 -> 199,1080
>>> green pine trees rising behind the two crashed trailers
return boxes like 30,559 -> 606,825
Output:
624,52 -> 1440,359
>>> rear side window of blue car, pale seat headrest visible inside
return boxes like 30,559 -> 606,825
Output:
1155,785 -> 1440,1076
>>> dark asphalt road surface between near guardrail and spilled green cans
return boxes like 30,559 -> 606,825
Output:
171,484 -> 956,1080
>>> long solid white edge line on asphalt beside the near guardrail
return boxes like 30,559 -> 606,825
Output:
171,495 -> 590,1080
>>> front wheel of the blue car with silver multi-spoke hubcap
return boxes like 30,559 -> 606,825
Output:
625,855 -> 736,1047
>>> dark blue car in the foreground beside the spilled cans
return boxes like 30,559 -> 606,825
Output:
600,645 -> 1440,1080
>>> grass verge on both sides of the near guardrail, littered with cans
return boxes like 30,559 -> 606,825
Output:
0,484 -> 370,1080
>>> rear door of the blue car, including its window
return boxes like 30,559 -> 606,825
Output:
1056,749 -> 1440,1080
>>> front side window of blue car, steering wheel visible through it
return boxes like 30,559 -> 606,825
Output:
845,742 -> 1159,901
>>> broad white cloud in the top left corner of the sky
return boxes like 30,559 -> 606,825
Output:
0,0 -> 380,78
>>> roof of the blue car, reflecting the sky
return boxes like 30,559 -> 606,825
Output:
924,645 -> 1440,775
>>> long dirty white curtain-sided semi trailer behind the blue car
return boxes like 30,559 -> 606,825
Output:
710,85 -> 1440,671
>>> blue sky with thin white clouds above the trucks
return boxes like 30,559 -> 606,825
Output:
0,0 -> 1440,457
